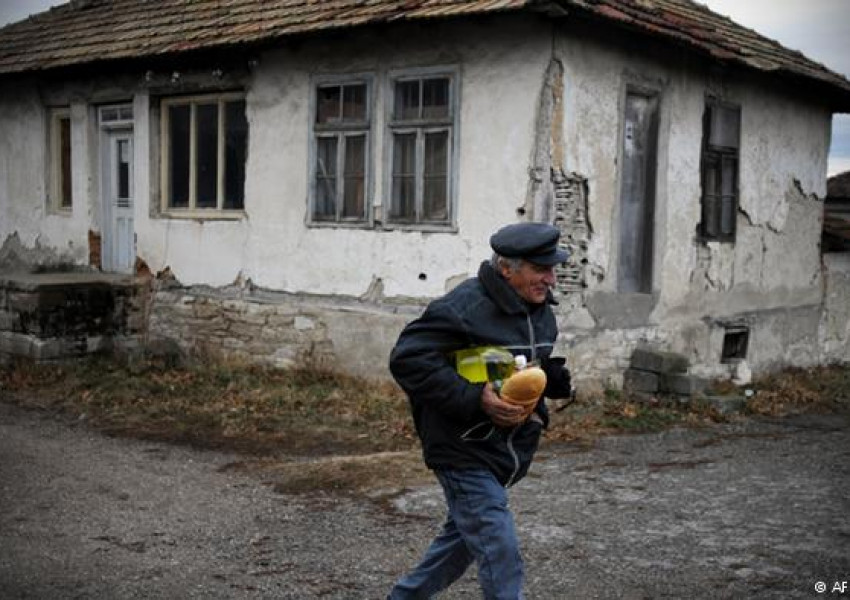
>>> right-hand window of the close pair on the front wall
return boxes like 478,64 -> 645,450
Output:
388,73 -> 456,225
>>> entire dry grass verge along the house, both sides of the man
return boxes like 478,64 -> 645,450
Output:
0,358 -> 850,496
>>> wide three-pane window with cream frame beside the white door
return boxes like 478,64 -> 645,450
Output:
161,93 -> 248,215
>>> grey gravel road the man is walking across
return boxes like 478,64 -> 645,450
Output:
0,402 -> 850,600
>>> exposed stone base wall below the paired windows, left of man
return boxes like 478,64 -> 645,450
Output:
148,285 -> 418,378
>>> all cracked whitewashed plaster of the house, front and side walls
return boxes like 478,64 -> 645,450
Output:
0,18 -> 846,378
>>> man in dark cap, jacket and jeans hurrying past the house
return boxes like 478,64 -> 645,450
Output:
389,223 -> 571,600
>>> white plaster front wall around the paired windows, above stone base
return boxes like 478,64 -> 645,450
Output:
127,19 -> 551,297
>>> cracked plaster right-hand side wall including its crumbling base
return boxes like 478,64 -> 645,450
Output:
544,23 -> 831,376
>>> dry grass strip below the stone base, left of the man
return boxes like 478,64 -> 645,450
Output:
0,359 -> 414,455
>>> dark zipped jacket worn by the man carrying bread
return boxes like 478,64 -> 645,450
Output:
390,262 -> 570,486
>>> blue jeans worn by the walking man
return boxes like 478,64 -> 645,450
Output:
389,469 -> 523,600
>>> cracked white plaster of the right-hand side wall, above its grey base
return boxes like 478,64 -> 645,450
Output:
558,27 -> 830,323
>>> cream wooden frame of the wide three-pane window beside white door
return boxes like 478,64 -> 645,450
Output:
160,92 -> 250,219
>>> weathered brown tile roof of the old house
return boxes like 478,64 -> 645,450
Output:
0,0 -> 850,106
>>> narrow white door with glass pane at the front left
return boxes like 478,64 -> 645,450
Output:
101,130 -> 136,273
